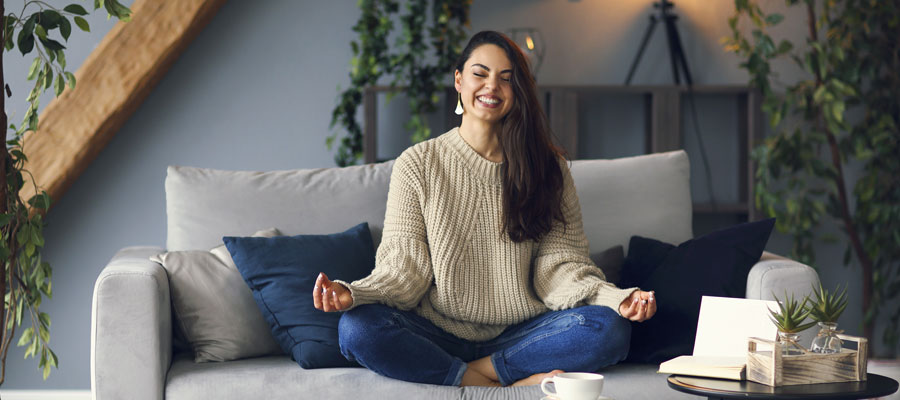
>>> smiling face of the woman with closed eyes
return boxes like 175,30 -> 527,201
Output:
455,44 -> 515,123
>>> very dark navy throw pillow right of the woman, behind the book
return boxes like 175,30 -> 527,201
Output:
622,218 -> 775,363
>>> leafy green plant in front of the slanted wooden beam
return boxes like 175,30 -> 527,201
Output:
0,0 -> 131,384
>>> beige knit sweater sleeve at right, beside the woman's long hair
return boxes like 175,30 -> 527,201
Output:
532,162 -> 637,313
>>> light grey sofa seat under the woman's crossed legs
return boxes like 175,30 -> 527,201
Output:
165,356 -> 697,400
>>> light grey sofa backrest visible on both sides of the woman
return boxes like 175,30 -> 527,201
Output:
166,151 -> 692,253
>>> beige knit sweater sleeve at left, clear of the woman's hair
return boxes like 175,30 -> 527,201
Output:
335,150 -> 433,310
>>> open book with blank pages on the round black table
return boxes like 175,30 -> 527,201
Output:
658,296 -> 778,380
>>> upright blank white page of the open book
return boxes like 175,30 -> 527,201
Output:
694,296 -> 778,360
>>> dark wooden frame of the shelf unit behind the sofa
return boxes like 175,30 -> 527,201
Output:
363,85 -> 763,221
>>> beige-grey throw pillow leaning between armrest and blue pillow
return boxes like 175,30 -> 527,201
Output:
150,228 -> 284,363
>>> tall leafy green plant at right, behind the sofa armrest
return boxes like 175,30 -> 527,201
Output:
724,0 -> 900,354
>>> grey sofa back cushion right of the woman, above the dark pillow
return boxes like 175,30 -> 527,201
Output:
571,150 -> 694,253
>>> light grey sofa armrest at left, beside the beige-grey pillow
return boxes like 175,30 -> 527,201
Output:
91,247 -> 172,400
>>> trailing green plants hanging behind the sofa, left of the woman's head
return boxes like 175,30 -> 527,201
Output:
326,0 -> 472,167
